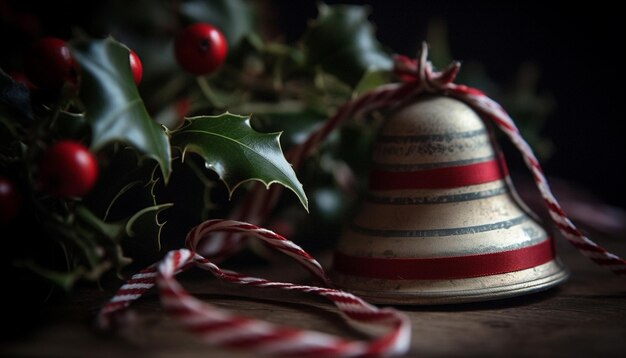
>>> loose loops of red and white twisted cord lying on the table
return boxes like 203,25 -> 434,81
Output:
98,220 -> 411,357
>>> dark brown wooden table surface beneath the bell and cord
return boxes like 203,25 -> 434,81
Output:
0,234 -> 626,357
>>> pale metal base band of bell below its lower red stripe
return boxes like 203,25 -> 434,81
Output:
331,258 -> 569,305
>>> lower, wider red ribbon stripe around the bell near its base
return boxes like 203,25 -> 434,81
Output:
333,239 -> 555,280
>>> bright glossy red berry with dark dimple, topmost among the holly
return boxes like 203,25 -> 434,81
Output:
174,23 -> 228,75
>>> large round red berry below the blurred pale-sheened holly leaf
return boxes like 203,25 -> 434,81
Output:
39,140 -> 98,198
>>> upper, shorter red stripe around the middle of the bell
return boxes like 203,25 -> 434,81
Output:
369,155 -> 509,190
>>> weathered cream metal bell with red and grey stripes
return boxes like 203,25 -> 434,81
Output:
332,96 -> 568,304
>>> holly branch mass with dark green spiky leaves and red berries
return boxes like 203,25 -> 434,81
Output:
0,0 -> 400,296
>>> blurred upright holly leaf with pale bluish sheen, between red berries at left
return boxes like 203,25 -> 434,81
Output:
72,37 -> 172,180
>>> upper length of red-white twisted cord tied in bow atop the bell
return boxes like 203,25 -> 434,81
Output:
226,43 -> 626,274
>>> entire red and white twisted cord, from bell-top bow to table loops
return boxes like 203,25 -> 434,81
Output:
98,39 -> 626,357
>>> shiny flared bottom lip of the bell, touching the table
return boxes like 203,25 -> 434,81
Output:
331,258 -> 570,306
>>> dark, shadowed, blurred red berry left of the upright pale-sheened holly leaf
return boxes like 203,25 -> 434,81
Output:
24,37 -> 76,89
